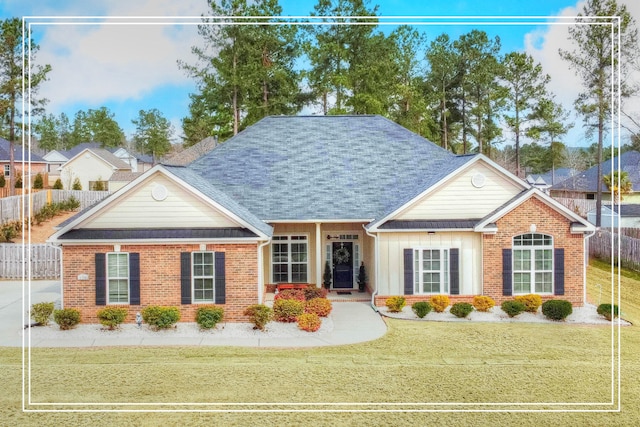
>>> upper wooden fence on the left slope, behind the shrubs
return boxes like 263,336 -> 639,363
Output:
0,190 -> 109,224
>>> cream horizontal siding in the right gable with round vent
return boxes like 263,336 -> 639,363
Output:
394,162 -> 523,220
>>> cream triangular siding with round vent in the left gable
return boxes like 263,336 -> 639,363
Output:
81,174 -> 240,228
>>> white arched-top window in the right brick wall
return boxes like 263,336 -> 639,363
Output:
513,233 -> 553,294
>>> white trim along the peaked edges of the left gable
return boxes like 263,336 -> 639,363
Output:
49,165 -> 270,243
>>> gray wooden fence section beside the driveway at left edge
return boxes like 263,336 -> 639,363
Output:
0,243 -> 61,279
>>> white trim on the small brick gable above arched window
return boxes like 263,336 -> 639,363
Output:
474,188 -> 595,234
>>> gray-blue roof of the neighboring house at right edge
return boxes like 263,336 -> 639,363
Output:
551,151 -> 640,193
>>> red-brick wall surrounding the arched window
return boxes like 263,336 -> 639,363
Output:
483,197 -> 584,306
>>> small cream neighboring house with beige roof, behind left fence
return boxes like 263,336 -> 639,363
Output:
60,148 -> 131,191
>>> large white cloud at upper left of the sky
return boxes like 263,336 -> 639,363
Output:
33,0 -> 206,110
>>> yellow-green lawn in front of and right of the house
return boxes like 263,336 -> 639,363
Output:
0,260 -> 640,426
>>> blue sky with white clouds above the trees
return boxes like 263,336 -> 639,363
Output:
0,0 -> 640,146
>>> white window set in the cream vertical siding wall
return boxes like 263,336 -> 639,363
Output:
413,249 -> 449,294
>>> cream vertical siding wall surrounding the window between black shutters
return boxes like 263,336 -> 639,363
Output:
378,232 -> 482,295
